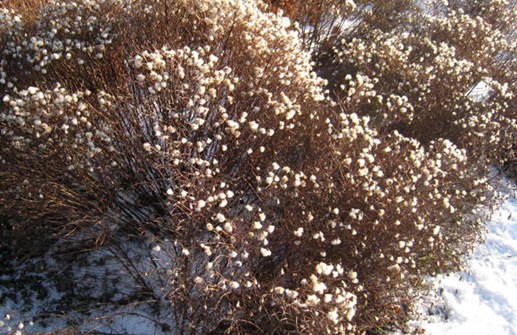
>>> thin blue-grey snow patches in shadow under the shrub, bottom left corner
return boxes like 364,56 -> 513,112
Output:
0,236 -> 172,335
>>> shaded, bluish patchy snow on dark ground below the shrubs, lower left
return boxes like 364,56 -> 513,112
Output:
0,236 -> 171,335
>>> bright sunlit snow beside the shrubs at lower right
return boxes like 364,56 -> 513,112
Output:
410,188 -> 517,335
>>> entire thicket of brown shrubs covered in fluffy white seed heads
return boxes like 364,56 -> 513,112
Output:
0,0 -> 516,334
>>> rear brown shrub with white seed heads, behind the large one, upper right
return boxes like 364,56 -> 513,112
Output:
268,0 -> 517,164
